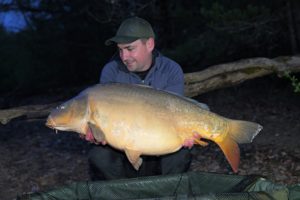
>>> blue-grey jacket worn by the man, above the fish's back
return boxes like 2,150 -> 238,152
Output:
100,50 -> 184,95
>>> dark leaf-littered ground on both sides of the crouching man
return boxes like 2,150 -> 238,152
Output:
0,77 -> 300,200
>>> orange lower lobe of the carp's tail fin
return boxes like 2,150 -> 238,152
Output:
215,136 -> 240,173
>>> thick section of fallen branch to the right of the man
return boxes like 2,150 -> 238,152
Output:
185,56 -> 300,97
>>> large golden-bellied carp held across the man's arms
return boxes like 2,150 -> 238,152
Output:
46,84 -> 262,172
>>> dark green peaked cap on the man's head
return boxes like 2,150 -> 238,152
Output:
105,17 -> 155,45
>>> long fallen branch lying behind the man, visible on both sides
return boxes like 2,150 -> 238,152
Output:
0,56 -> 300,124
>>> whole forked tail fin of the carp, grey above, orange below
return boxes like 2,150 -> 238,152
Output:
215,120 -> 262,172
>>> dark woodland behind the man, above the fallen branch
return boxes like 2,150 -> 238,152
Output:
0,0 -> 300,96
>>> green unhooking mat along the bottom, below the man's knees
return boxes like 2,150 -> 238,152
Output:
17,172 -> 300,200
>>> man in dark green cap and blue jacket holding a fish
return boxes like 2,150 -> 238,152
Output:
89,17 -> 191,180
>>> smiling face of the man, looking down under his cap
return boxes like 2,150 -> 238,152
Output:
117,38 -> 154,72
